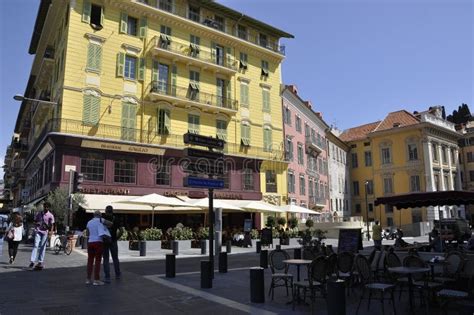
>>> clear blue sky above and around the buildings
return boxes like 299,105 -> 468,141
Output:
0,0 -> 474,175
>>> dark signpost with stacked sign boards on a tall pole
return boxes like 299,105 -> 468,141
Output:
183,133 -> 225,283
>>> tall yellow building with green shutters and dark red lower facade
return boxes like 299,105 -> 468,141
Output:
15,0 -> 292,228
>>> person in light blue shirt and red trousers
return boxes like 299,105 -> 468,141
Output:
86,210 -> 110,285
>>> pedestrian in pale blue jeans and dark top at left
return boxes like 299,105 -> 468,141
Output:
29,202 -> 54,270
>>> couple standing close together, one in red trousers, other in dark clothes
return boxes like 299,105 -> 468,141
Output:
86,206 -> 122,285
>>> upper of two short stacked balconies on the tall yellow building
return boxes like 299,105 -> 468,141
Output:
152,35 -> 238,75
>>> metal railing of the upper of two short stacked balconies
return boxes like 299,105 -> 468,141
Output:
154,36 -> 238,71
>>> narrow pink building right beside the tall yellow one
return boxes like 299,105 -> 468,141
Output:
282,85 -> 330,214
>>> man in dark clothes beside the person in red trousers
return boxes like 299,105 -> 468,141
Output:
102,206 -> 122,283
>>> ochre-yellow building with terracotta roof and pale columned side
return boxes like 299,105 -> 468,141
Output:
341,107 -> 460,230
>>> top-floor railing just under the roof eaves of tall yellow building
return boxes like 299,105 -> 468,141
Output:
136,0 -> 285,55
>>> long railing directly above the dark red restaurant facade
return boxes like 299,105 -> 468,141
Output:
30,118 -> 285,162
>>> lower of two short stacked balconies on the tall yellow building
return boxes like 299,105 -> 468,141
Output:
150,81 -> 238,114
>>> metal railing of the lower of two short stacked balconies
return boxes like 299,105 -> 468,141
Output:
151,81 -> 238,111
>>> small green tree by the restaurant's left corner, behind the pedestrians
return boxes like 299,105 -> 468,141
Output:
46,188 -> 86,231
